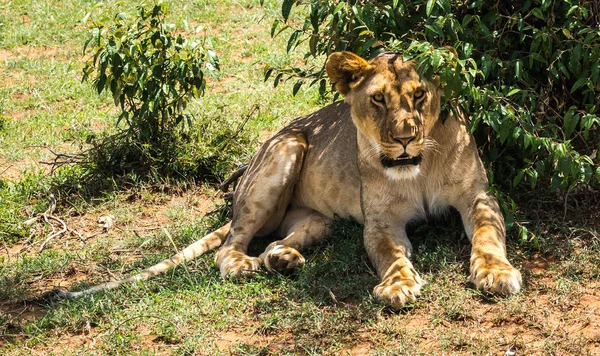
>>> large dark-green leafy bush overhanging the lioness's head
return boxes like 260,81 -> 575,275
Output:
274,0 -> 600,190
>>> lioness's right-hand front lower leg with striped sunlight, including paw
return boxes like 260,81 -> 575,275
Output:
457,191 -> 522,295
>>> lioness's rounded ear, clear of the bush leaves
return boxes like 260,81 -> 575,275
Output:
325,51 -> 371,95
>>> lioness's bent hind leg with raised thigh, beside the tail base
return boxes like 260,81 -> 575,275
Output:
215,133 -> 307,277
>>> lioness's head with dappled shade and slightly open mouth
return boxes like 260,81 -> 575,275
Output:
326,52 -> 440,179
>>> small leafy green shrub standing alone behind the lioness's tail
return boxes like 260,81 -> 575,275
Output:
83,1 -> 218,174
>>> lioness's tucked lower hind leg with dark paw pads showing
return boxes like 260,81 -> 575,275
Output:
259,208 -> 331,274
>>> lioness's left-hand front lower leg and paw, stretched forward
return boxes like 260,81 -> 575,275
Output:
364,218 -> 425,309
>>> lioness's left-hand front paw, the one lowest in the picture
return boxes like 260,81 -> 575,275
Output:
373,266 -> 425,310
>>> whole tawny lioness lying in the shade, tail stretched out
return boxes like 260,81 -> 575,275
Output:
60,52 -> 521,309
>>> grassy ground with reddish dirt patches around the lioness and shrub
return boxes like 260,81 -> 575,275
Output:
0,0 -> 600,355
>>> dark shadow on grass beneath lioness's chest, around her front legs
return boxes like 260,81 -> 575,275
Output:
250,212 -> 480,309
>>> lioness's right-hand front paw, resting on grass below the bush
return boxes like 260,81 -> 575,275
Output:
469,257 -> 522,295
